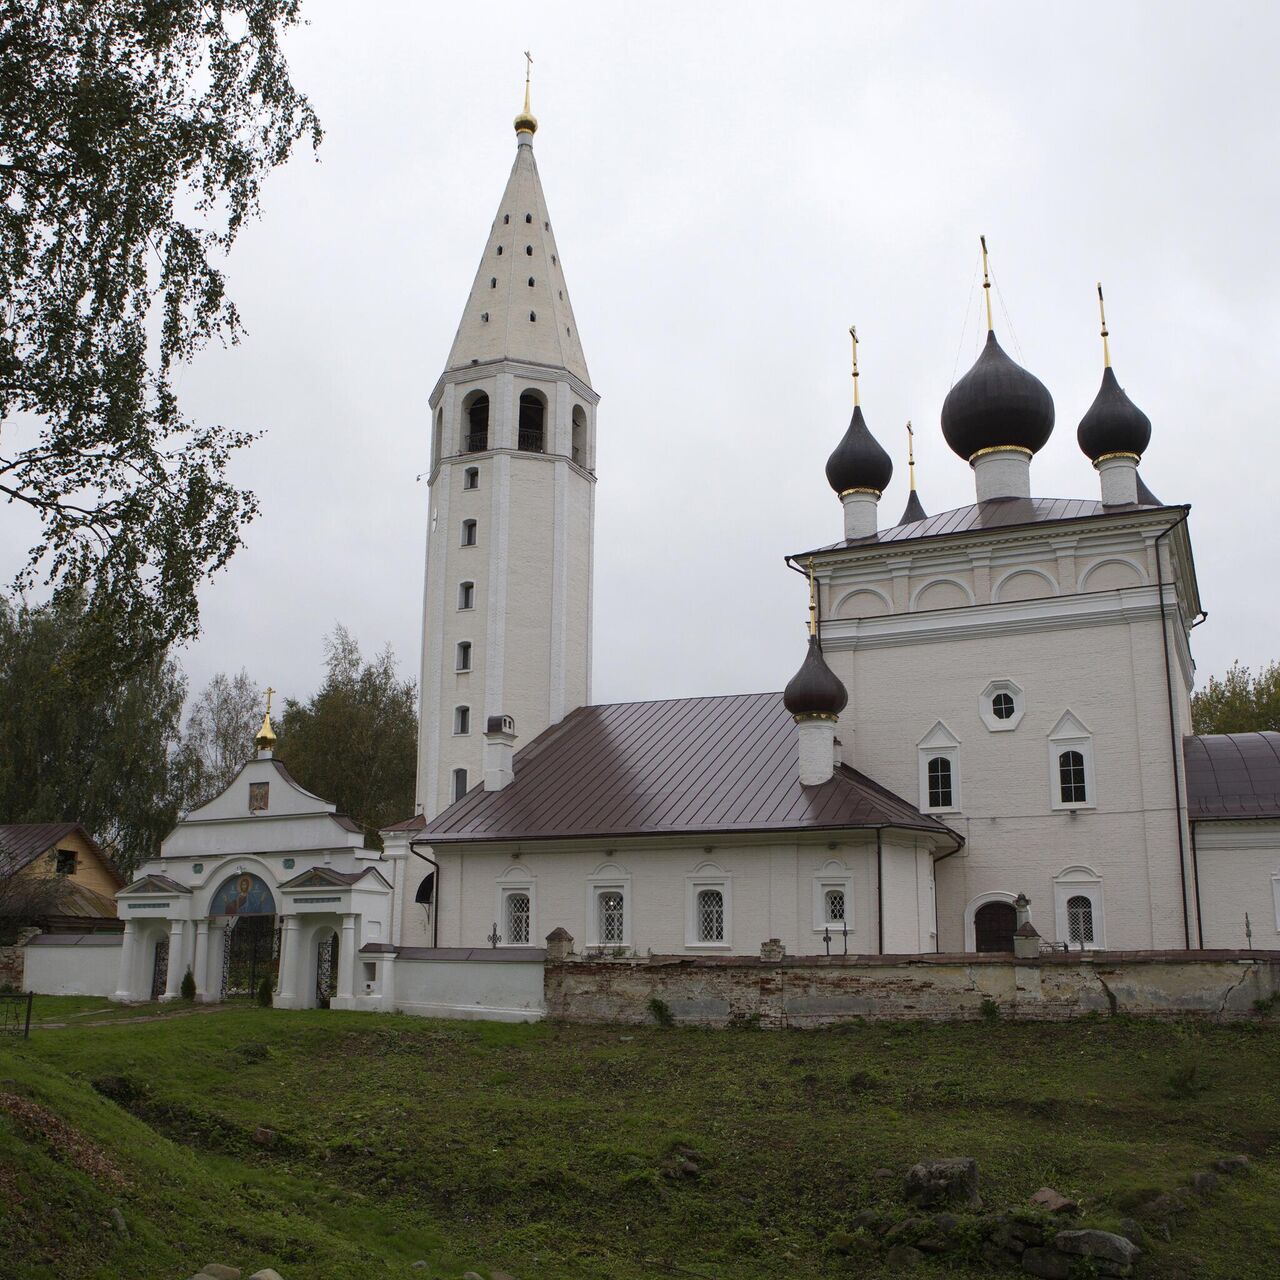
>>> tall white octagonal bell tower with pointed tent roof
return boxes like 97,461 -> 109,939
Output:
417,77 -> 599,818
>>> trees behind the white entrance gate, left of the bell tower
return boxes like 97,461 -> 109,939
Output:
0,594 -> 417,874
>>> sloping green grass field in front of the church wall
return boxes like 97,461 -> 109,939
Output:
0,1000 -> 1280,1280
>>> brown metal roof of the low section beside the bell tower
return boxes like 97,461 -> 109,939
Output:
425,694 -> 960,847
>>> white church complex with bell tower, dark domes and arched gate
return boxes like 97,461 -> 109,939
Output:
104,87 -> 1280,1011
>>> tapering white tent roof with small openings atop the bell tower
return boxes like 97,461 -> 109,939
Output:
445,134 -> 591,385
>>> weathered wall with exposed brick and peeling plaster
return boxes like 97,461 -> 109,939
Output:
544,951 -> 1280,1027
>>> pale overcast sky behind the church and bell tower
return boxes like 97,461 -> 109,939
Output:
10,0 -> 1280,701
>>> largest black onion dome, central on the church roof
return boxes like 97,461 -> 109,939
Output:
942,330 -> 1053,462
